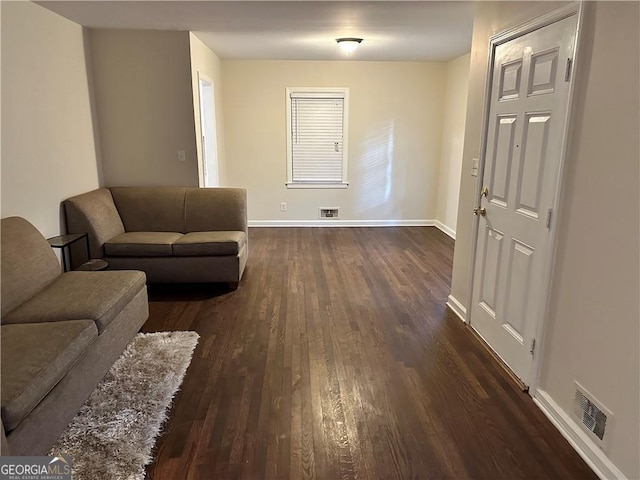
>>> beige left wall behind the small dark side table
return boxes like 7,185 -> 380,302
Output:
0,2 -> 100,237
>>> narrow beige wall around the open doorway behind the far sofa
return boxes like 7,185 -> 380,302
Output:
189,33 -> 226,186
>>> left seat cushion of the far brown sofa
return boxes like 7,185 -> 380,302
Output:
104,232 -> 182,257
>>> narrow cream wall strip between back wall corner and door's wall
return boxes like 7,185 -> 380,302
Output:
436,53 -> 471,238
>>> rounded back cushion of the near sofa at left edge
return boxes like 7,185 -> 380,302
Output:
0,217 -> 61,316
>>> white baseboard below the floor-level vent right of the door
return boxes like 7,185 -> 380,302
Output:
533,389 -> 627,480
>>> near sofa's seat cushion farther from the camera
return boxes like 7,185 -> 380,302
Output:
2,270 -> 146,333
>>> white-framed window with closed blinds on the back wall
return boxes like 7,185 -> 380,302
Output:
287,88 -> 349,188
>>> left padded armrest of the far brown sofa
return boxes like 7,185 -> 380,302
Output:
64,188 -> 124,258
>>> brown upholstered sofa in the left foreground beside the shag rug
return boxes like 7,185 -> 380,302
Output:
0,217 -> 149,455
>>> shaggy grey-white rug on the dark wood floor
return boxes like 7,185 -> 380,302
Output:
51,332 -> 199,480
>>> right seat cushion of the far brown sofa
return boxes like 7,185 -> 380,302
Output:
173,232 -> 247,257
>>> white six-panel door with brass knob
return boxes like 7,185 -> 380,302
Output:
470,15 -> 577,385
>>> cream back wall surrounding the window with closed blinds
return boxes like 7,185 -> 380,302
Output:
222,60 -> 446,222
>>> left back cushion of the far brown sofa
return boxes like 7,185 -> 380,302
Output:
111,187 -> 186,233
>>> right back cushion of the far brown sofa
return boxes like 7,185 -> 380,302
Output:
185,187 -> 247,233
